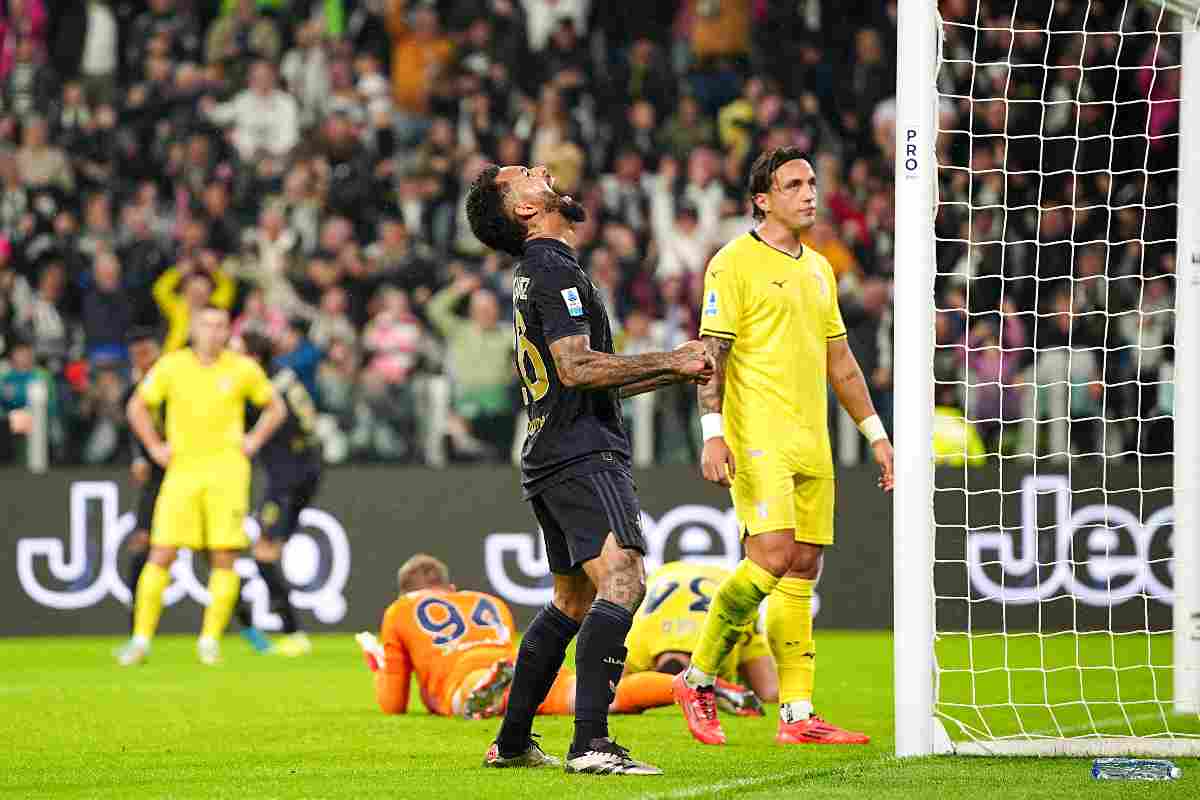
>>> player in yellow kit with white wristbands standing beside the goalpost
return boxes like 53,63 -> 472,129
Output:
674,148 -> 893,745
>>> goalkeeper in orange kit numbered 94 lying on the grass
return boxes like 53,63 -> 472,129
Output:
359,554 -> 762,720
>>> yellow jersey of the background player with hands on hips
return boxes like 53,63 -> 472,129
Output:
138,348 -> 275,465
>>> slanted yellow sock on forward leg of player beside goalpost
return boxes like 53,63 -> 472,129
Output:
688,559 -> 782,686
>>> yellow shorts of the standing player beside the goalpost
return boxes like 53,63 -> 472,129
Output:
730,457 -> 836,546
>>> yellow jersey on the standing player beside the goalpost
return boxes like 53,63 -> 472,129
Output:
700,231 -> 846,477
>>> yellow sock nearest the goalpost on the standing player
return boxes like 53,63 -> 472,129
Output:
767,578 -> 816,716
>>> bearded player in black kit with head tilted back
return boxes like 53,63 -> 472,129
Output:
467,166 -> 712,775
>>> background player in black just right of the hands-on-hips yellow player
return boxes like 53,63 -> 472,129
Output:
238,332 -> 322,656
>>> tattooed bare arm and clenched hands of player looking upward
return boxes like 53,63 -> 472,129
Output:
550,333 -> 712,391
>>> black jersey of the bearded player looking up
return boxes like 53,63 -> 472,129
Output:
512,239 -> 630,498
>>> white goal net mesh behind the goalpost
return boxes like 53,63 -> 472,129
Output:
934,0 -> 1200,742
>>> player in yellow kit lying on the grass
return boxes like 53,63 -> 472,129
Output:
625,561 -> 779,716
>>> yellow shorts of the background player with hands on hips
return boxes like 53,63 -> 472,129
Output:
150,462 -> 250,551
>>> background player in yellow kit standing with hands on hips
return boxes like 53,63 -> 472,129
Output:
118,306 -> 287,666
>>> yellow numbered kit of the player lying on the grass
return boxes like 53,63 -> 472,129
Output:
625,561 -> 770,681
